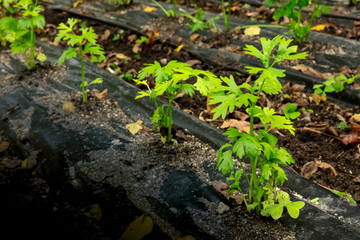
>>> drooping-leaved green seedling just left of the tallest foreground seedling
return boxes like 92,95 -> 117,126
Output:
134,60 -> 220,143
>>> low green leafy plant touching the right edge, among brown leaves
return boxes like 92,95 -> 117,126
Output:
313,74 -> 360,97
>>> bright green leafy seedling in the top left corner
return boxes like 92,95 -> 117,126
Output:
0,0 -> 46,69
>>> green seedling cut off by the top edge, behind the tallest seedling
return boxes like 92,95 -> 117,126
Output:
265,0 -> 331,43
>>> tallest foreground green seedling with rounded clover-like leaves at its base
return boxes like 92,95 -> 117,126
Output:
209,35 -> 308,219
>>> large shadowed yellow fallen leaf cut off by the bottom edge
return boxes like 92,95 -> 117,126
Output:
120,215 -> 153,240
